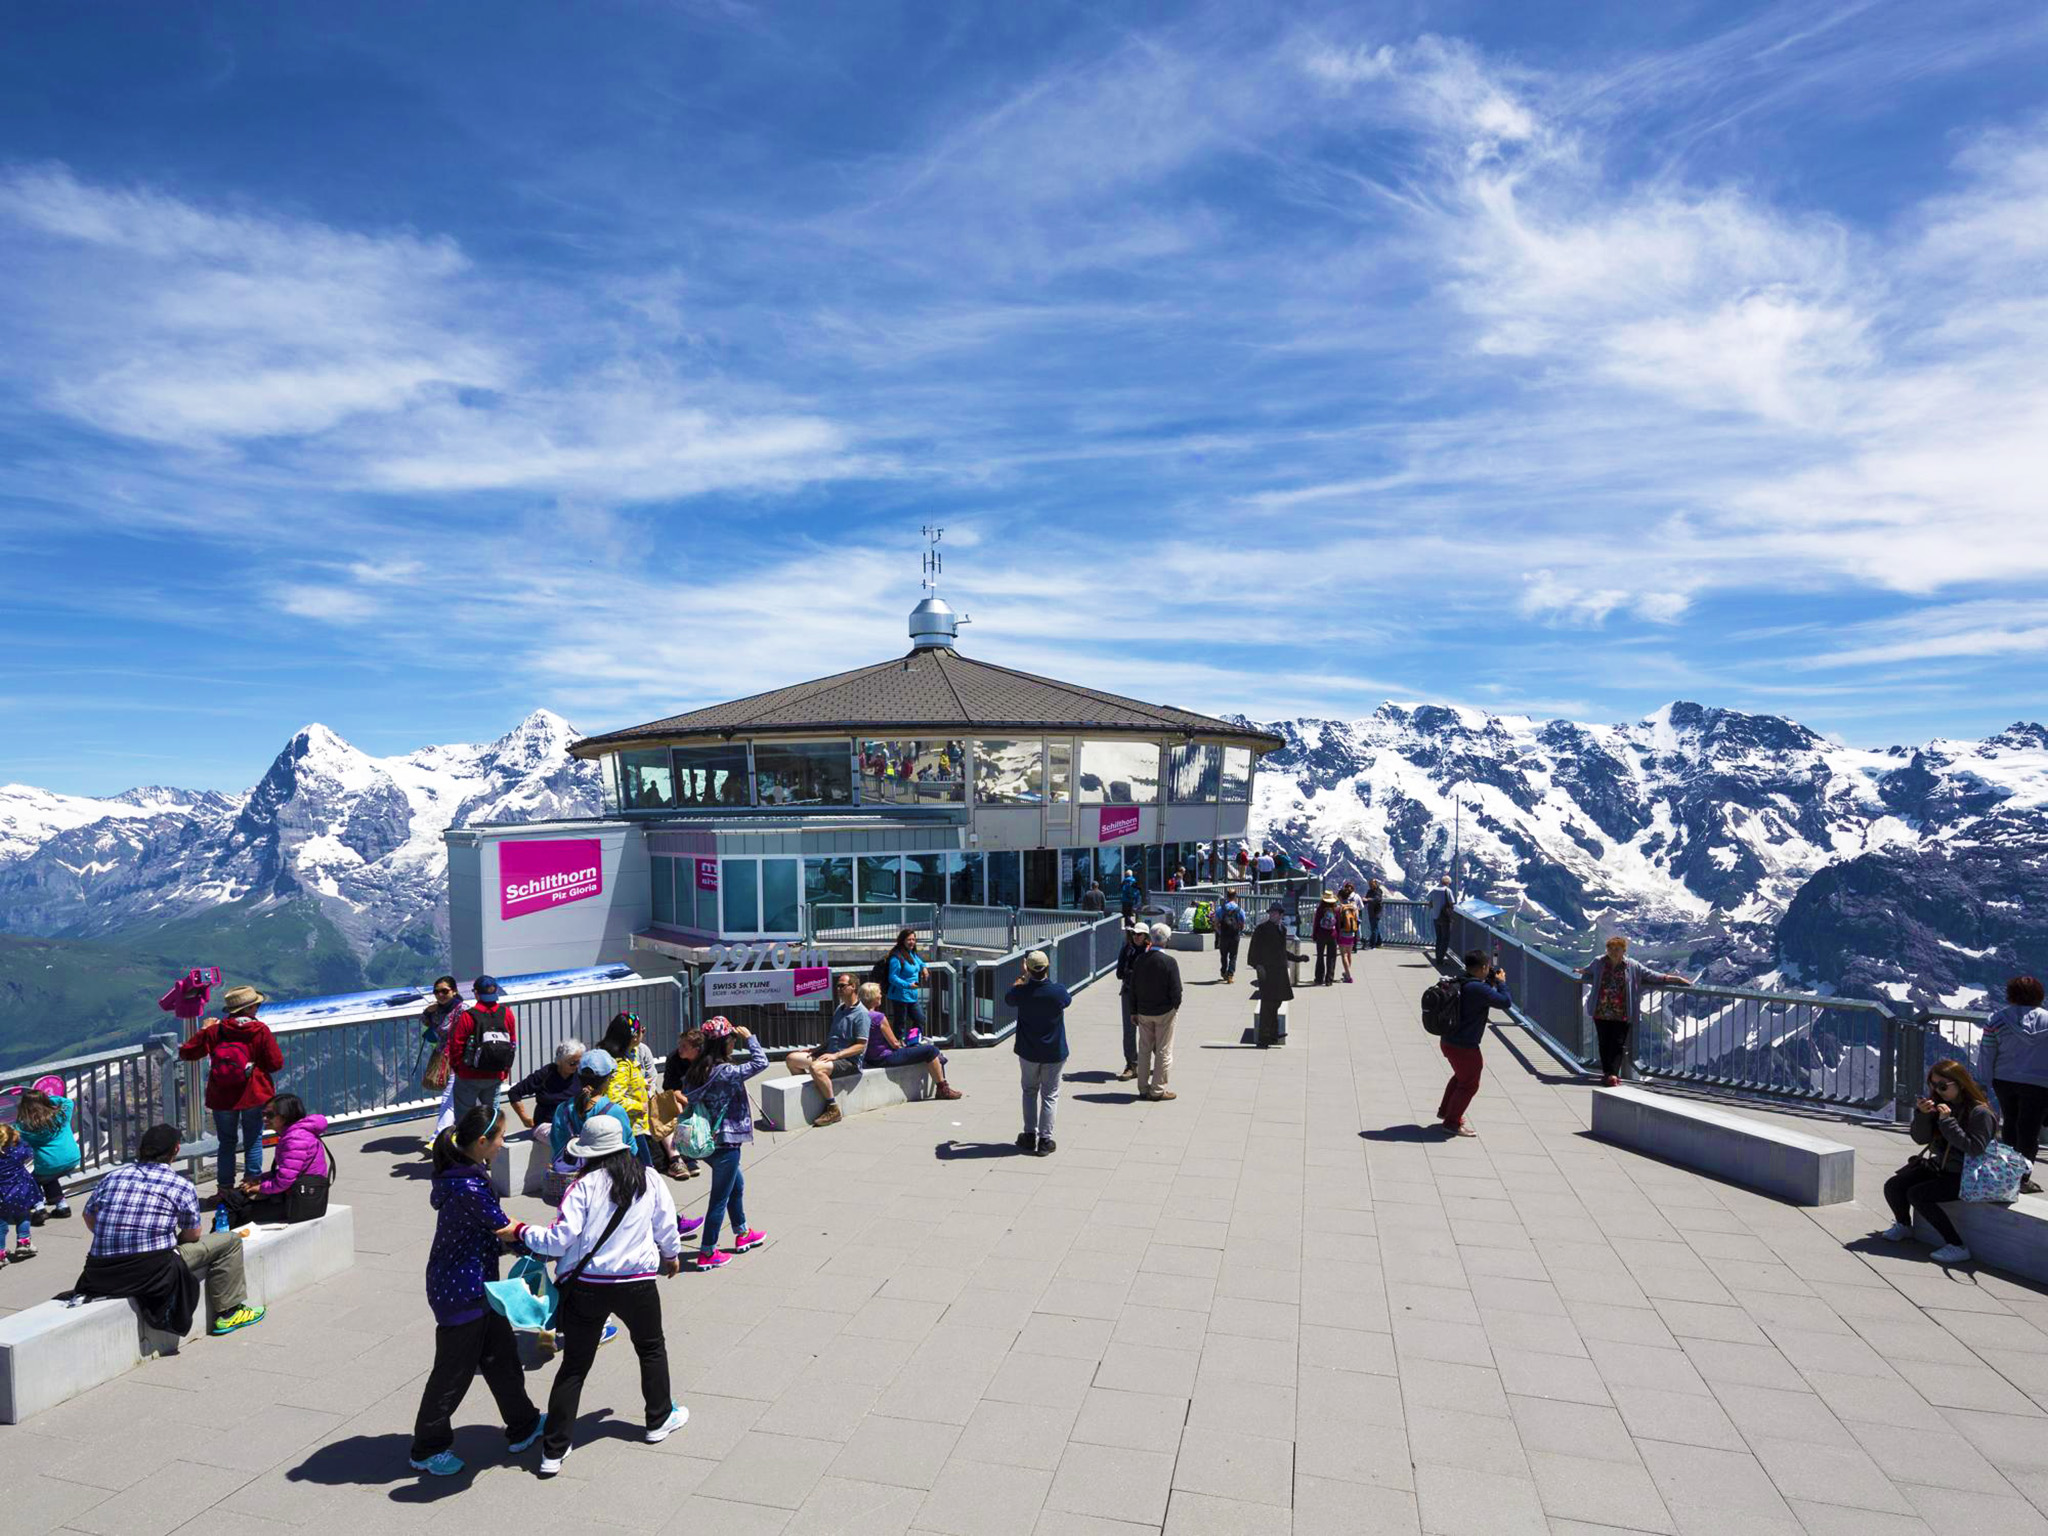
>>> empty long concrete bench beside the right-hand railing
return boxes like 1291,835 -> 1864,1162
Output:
1593,1087 -> 1855,1206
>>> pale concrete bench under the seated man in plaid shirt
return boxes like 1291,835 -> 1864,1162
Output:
0,1206 -> 356,1423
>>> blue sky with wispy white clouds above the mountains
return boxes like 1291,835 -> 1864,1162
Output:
0,0 -> 2048,793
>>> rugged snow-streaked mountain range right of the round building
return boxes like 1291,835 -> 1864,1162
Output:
1253,702 -> 2048,1006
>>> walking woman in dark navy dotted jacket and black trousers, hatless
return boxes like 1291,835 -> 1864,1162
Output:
410,1104 -> 547,1477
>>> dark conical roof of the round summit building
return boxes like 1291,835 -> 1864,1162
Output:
573,647 -> 1284,758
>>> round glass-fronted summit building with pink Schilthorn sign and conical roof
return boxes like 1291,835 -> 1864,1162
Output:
446,575 -> 1282,975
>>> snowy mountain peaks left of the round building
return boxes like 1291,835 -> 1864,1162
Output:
0,711 -> 600,954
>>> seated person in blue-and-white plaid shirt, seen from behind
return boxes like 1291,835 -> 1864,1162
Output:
72,1124 -> 266,1337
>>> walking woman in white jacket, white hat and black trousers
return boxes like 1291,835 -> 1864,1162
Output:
518,1114 -> 688,1477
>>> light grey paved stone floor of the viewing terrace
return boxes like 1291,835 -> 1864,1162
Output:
0,952 -> 2048,1536
